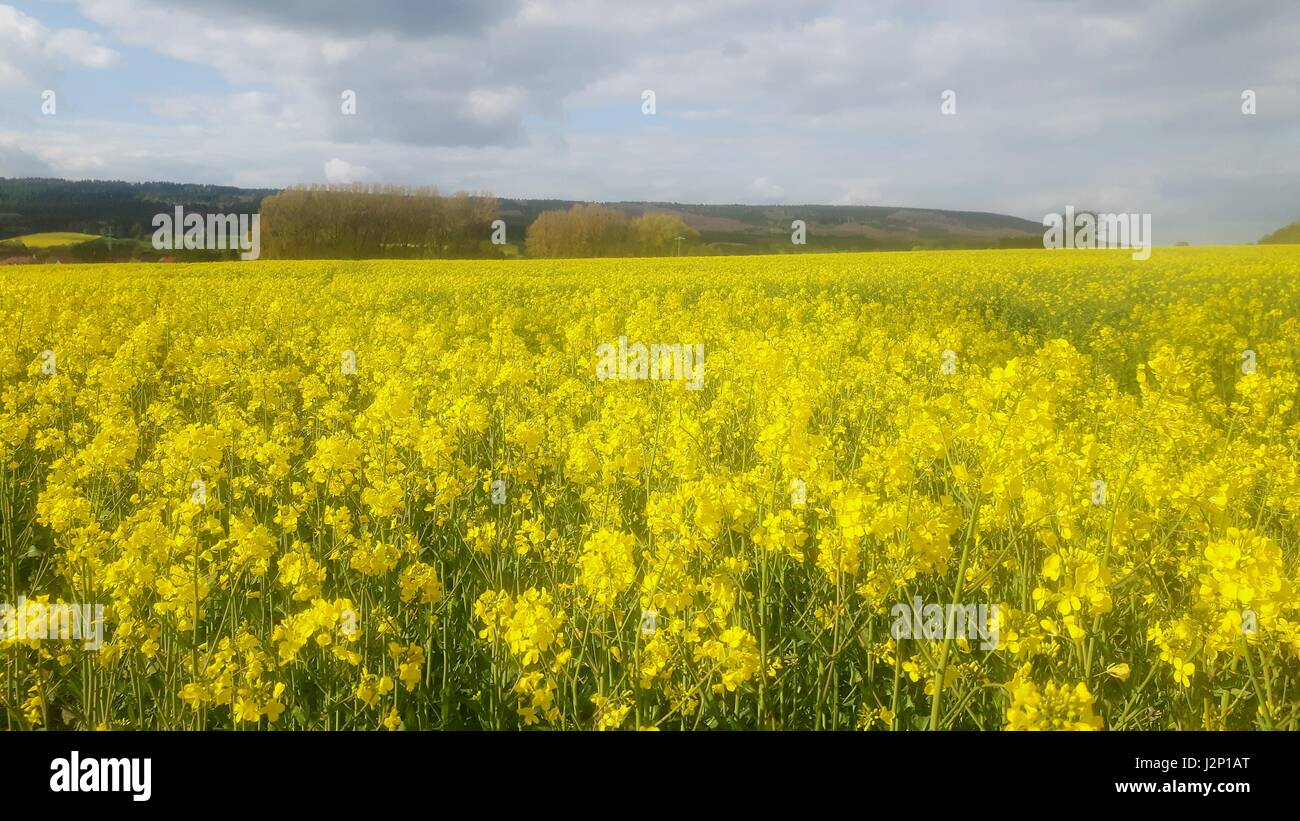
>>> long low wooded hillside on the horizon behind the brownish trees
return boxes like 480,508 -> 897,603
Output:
0,178 -> 1043,253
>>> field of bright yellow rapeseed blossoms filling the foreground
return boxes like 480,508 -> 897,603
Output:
0,247 -> 1300,730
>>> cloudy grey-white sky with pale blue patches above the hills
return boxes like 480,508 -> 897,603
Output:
0,0 -> 1300,244
